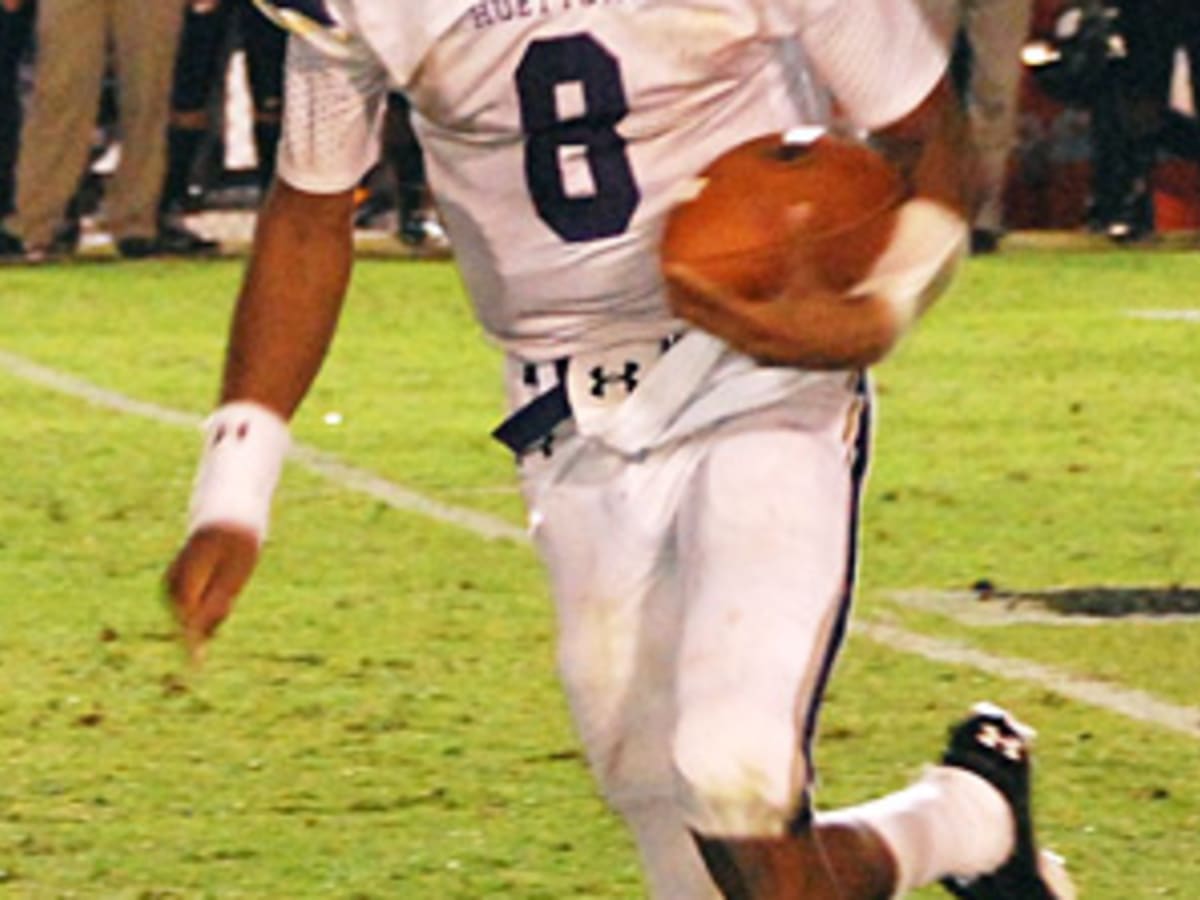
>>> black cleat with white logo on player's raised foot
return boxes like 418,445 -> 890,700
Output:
942,703 -> 1075,900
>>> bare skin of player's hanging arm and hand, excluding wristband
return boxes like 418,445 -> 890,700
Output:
167,181 -> 353,649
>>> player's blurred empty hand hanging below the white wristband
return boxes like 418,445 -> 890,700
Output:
166,526 -> 258,660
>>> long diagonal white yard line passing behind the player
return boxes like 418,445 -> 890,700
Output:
0,350 -> 1200,738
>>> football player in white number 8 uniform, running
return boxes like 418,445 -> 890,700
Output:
168,0 -> 1068,900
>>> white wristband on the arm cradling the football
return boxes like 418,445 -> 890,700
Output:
854,198 -> 967,330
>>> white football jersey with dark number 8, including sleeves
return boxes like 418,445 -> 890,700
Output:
278,0 -> 946,360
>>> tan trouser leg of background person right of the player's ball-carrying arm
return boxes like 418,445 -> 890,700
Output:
922,0 -> 1033,253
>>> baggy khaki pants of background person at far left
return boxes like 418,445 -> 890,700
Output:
14,0 -> 186,248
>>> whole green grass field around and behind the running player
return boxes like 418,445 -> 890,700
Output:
0,252 -> 1200,900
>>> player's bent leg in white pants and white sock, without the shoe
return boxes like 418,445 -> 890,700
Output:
674,400 -> 1070,900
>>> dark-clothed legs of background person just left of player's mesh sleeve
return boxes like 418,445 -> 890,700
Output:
161,0 -> 287,223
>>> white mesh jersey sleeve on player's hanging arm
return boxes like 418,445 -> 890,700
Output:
277,29 -> 388,193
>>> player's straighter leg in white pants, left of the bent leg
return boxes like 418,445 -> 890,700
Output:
513,420 -> 718,900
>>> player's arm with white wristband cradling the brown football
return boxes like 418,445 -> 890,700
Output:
665,80 -> 971,370
